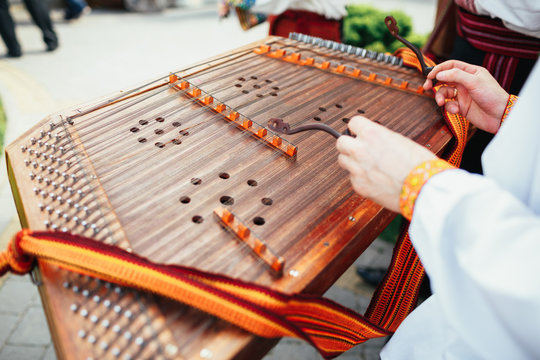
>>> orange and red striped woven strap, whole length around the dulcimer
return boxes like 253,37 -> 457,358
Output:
0,47 -> 467,358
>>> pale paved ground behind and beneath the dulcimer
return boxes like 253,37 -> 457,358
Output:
0,0 -> 435,360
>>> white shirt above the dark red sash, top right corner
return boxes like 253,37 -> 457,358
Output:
475,0 -> 540,38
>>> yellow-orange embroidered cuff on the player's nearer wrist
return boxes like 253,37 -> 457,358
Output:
399,159 -> 456,221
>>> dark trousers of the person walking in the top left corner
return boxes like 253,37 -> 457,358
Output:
0,0 -> 58,53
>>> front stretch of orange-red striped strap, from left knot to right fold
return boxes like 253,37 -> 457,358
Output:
0,230 -> 389,358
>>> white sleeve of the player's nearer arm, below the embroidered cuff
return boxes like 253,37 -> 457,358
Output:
408,170 -> 540,359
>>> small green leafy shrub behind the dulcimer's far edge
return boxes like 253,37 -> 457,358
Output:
342,5 -> 427,53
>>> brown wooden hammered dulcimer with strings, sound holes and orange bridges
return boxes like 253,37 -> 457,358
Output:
8,38 -> 448,358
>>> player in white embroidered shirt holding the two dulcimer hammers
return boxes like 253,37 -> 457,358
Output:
336,60 -> 540,360
